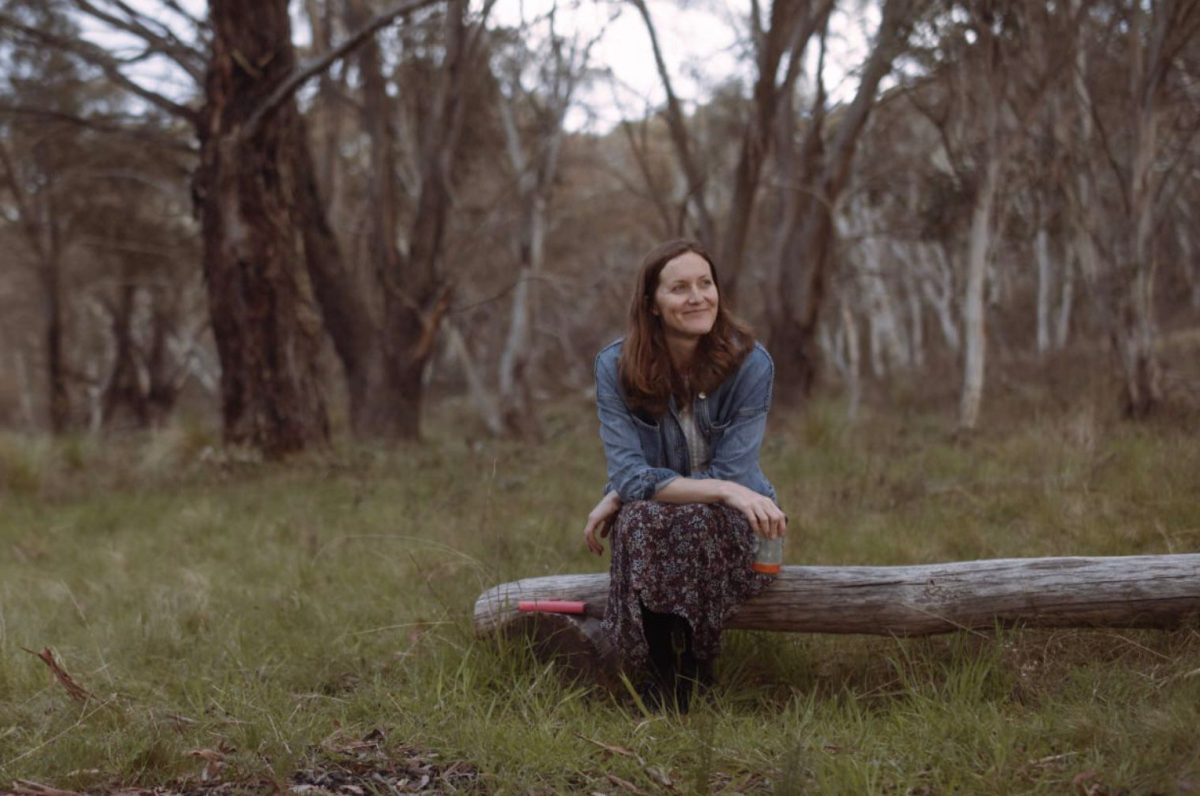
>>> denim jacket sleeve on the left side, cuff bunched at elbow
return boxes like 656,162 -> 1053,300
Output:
595,357 -> 679,503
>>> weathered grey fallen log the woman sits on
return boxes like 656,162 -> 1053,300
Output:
475,553 -> 1200,638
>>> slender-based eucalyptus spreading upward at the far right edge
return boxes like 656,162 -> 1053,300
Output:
1063,0 -> 1200,418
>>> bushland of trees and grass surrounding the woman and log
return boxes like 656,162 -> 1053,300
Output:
0,0 -> 1200,792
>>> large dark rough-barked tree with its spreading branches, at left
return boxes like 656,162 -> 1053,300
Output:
0,0 -> 451,456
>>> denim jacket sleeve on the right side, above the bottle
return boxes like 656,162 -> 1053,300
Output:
696,347 -> 775,490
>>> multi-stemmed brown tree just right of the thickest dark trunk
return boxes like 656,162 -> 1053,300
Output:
308,0 -> 494,441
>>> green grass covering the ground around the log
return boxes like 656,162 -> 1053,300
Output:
0,405 -> 1200,794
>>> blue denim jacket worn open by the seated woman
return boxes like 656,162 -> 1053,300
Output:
595,340 -> 775,503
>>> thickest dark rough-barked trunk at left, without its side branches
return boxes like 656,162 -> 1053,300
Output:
194,0 -> 329,457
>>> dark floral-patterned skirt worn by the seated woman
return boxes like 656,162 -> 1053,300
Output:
602,501 -> 773,669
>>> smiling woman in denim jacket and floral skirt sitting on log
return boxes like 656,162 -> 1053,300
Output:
583,240 -> 787,710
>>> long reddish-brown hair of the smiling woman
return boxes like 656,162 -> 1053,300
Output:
619,239 -> 754,417
